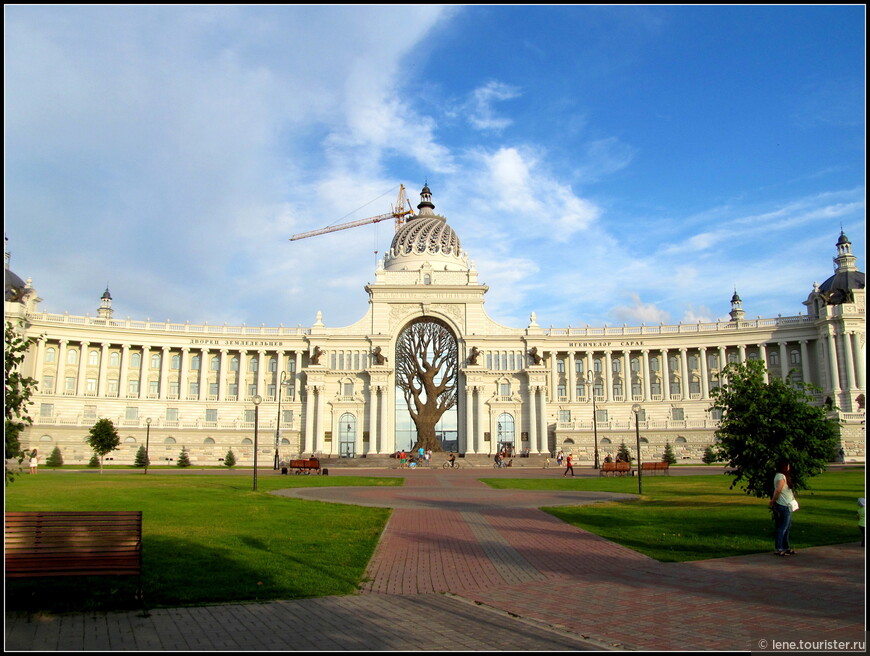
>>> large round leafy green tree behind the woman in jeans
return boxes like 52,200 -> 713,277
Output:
711,360 -> 840,497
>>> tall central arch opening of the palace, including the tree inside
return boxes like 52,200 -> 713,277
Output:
395,317 -> 459,451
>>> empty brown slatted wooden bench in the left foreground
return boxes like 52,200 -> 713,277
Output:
5,510 -> 147,614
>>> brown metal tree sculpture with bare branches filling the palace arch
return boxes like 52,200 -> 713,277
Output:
396,318 -> 459,451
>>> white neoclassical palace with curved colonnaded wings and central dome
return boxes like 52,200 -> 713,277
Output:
5,187 -> 865,466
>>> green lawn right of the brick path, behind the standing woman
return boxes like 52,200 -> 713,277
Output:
485,468 -> 866,562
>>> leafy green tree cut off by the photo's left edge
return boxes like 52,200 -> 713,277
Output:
4,321 -> 37,485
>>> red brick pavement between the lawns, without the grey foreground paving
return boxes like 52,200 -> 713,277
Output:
346,471 -> 864,650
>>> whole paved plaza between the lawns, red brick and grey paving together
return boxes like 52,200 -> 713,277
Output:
5,469 -> 865,651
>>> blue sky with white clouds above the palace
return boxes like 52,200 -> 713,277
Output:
4,5 -> 866,327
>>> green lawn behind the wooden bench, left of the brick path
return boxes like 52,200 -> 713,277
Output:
6,471 -> 403,611
